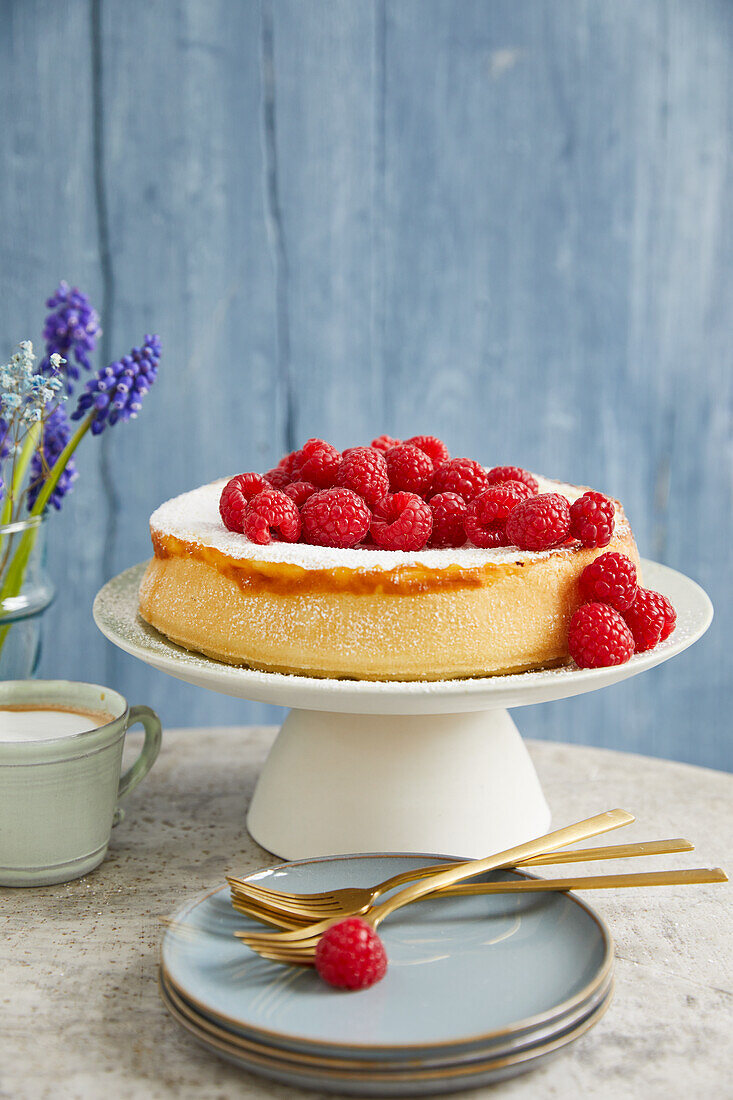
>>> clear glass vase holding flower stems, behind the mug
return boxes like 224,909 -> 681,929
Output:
0,516 -> 55,680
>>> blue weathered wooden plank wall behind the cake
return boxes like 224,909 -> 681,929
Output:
0,0 -> 733,765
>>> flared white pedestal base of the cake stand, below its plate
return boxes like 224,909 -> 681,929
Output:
247,710 -> 550,859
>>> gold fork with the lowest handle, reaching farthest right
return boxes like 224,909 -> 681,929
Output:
232,867 -> 727,937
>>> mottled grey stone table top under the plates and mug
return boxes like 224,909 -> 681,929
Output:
0,728 -> 733,1100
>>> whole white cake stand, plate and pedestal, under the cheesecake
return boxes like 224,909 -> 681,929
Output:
94,561 -> 713,859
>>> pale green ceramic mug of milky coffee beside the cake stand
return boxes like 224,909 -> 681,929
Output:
0,680 -> 161,887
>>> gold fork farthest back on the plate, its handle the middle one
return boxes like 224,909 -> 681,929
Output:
227,837 -> 694,928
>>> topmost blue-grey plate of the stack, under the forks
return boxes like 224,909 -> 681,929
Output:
162,856 -> 613,1059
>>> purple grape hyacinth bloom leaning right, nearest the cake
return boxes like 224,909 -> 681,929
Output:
72,336 -> 161,436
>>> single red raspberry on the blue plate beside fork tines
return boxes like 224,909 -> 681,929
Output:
316,916 -> 387,989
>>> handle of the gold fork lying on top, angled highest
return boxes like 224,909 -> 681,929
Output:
367,810 -> 634,927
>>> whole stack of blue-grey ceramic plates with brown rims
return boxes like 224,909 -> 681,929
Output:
161,856 -> 613,1096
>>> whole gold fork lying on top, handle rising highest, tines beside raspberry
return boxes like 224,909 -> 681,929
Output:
234,810 -> 634,965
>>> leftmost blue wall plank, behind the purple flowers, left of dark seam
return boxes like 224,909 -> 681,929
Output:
0,0 -> 106,682
